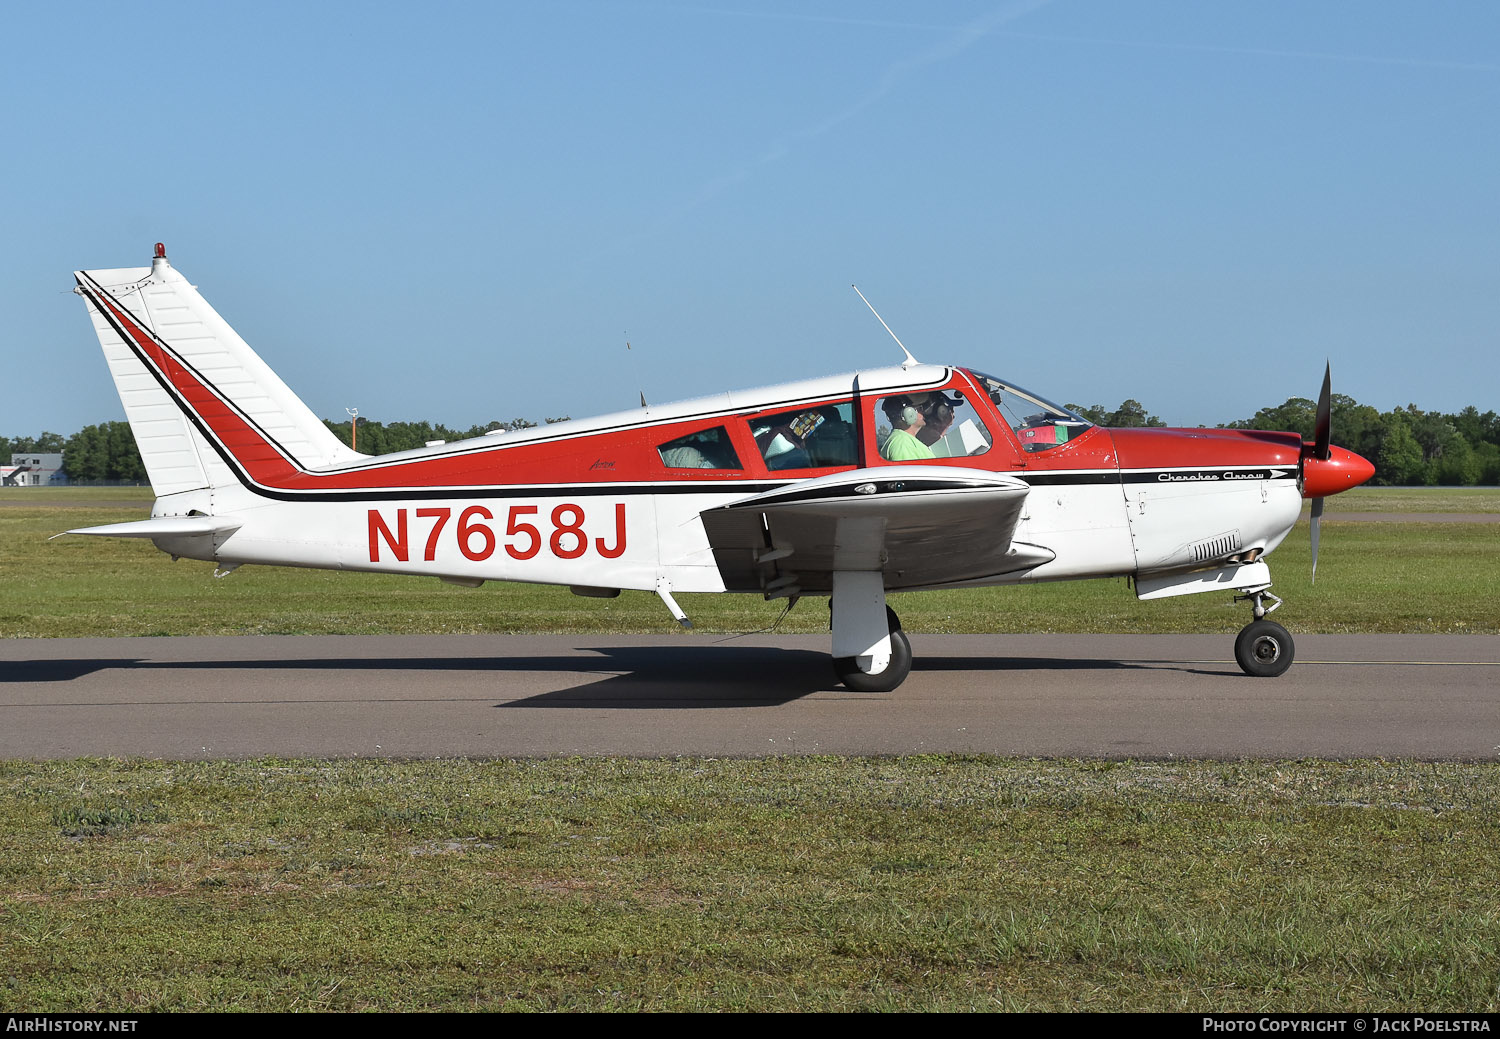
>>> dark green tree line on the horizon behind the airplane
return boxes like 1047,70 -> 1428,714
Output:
11,393 -> 1500,486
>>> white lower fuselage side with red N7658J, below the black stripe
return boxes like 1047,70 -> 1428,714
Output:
153,458 -> 1302,592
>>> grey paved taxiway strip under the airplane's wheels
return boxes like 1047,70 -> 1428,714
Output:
0,634 -> 1500,760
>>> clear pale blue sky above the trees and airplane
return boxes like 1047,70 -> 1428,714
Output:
0,0 -> 1500,438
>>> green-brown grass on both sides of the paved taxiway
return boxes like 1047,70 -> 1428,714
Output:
0,487 -> 1500,1012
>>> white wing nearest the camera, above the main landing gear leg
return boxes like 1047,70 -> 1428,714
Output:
701,465 -> 1055,595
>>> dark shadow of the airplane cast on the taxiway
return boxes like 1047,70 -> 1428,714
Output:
0,646 -> 1238,709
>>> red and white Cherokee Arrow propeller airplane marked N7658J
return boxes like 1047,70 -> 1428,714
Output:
69,244 -> 1374,691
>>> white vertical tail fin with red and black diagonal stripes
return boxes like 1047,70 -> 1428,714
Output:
74,244 -> 366,496
